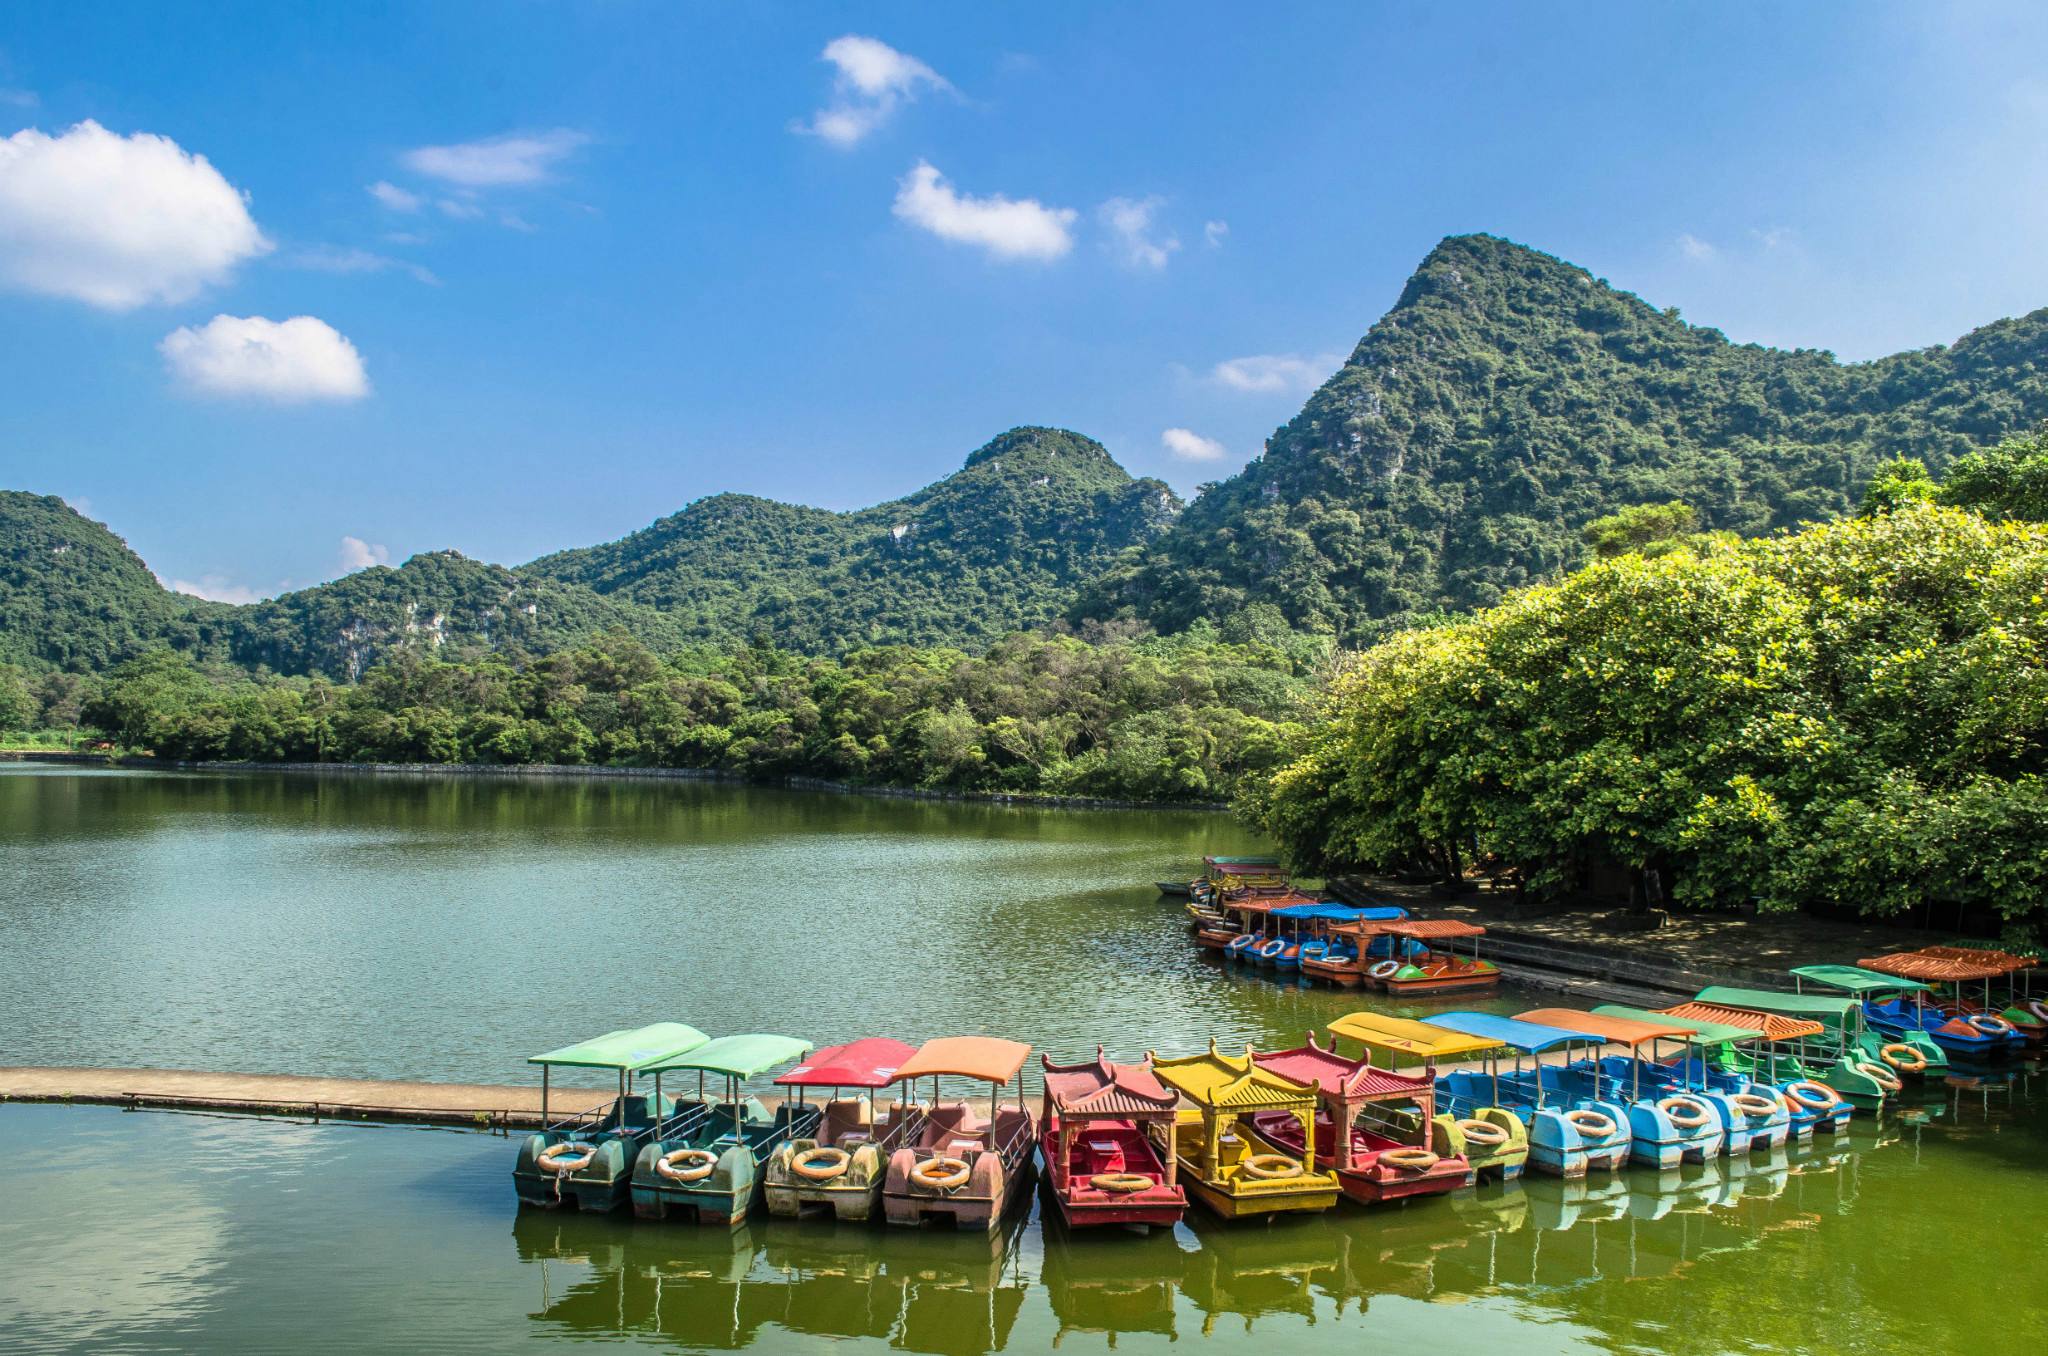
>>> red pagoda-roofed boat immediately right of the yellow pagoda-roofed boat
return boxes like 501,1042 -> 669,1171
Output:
1247,1032 -> 1475,1204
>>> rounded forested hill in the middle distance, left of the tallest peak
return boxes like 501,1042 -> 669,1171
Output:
520,428 -> 1180,651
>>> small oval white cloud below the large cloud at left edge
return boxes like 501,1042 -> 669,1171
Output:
158,315 -> 371,404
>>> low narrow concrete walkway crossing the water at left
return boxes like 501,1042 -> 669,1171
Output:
0,1065 -> 612,1129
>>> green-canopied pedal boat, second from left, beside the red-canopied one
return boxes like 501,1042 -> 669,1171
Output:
633,1032 -> 821,1229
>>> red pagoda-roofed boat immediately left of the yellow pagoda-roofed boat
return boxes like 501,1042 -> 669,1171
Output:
1038,1045 -> 1188,1229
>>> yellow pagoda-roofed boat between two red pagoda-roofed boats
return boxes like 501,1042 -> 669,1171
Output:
1147,1041 -> 1339,1219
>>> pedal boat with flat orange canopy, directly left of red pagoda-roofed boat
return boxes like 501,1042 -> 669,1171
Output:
883,1036 -> 1036,1233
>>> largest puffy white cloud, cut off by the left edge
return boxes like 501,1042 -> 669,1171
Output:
0,121 -> 270,311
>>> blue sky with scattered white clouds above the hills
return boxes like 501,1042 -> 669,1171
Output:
0,0 -> 2048,598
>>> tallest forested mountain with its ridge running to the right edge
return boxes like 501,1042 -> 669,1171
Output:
1077,236 -> 2048,637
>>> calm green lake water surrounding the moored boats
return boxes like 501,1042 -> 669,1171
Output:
0,768 -> 2048,1354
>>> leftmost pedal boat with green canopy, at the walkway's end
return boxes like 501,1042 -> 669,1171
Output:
512,1022 -> 709,1211
